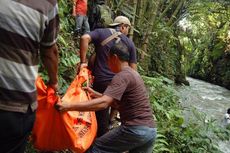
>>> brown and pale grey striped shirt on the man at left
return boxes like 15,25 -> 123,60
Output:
0,0 -> 59,112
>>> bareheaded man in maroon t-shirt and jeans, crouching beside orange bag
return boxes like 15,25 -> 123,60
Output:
57,42 -> 156,153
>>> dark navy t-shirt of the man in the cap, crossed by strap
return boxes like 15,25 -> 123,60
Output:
89,28 -> 137,83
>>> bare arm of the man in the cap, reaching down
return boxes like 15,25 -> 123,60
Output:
80,34 -> 91,63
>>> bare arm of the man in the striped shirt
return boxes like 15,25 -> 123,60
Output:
41,44 -> 58,90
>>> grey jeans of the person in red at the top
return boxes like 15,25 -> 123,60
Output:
76,15 -> 90,34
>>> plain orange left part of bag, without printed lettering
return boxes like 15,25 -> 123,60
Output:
32,77 -> 71,151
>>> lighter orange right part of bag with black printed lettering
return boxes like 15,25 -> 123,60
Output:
62,68 -> 97,153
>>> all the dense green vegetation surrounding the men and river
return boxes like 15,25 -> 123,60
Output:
28,0 -> 230,153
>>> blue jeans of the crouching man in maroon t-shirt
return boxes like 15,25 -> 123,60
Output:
87,125 -> 156,153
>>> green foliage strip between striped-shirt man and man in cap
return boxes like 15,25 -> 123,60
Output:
40,0 -> 80,94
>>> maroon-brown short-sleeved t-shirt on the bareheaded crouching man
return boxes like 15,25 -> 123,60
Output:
104,66 -> 155,127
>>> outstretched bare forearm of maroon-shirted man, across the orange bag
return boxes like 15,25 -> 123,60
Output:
56,95 -> 113,111
